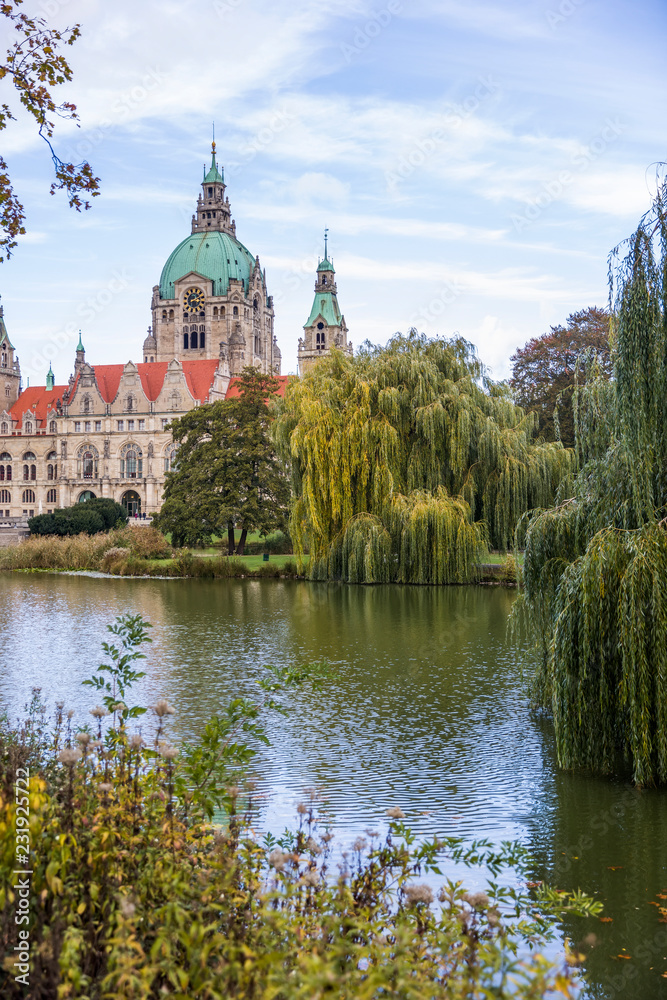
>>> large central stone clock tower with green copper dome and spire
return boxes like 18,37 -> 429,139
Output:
143,142 -> 281,375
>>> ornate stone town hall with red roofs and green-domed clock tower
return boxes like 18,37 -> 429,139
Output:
0,143 -> 352,520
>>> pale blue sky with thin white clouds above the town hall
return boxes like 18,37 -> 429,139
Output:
0,0 -> 667,384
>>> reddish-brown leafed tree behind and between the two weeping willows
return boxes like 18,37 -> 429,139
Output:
509,306 -> 611,448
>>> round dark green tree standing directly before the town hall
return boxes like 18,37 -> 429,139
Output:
158,367 -> 289,555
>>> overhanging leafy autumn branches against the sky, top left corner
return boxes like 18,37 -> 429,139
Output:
0,0 -> 99,261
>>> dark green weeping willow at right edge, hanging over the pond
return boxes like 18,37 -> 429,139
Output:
522,185 -> 667,785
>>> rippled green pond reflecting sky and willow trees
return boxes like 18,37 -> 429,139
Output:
0,574 -> 667,1000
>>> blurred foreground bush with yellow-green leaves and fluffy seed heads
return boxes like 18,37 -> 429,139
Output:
0,616 -> 596,1000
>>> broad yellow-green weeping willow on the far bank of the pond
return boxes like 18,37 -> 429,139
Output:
273,331 -> 573,584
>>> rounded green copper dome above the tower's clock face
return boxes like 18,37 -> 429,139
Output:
160,231 -> 255,299
